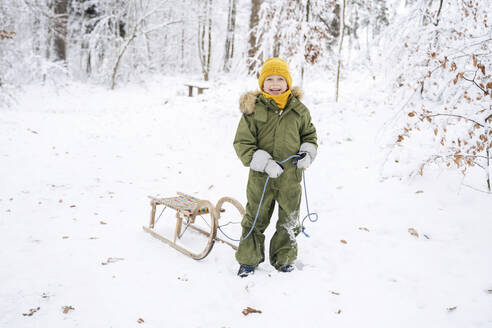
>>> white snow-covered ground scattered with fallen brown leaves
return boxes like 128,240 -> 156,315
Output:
0,74 -> 492,328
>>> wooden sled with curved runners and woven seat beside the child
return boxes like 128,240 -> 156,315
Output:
143,192 -> 245,260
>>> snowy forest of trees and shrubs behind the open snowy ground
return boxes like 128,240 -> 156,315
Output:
0,0 -> 492,186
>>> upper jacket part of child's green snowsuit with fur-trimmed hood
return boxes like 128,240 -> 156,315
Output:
234,87 -> 318,184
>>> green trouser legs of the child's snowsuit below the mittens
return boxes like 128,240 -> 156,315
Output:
236,168 -> 302,269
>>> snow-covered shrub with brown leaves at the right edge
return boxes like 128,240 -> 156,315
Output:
384,0 -> 492,189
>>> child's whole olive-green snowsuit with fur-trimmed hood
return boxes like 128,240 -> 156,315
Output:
234,88 -> 317,269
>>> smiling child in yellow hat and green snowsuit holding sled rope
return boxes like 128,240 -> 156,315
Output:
234,58 -> 318,277
